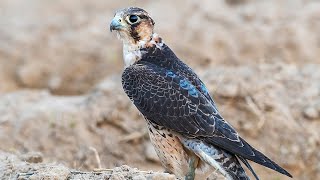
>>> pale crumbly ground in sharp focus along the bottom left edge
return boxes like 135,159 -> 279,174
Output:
0,152 -> 180,180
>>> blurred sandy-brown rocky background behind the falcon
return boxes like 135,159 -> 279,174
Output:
0,0 -> 320,180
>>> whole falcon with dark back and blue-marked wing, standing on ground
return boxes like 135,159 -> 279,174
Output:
110,7 -> 292,180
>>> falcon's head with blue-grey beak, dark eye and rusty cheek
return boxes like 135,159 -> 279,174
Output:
110,7 -> 154,44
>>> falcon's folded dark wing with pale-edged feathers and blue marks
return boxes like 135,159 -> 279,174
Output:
123,62 -> 239,142
